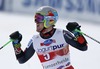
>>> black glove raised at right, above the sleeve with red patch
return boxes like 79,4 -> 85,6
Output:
66,22 -> 81,36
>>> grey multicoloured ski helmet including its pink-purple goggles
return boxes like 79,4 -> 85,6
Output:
35,6 -> 58,28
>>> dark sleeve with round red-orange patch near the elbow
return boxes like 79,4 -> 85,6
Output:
63,30 -> 88,51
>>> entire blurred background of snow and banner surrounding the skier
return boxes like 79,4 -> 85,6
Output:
0,0 -> 100,69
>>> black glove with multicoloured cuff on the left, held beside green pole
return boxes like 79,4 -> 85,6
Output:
10,31 -> 22,48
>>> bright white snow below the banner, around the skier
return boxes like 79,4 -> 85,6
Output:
0,12 -> 100,69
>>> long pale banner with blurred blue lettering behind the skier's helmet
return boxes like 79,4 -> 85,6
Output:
6,0 -> 100,22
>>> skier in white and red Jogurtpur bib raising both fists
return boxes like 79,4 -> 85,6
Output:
10,6 -> 87,69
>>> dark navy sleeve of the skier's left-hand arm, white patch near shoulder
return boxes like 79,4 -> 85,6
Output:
16,41 -> 35,64
